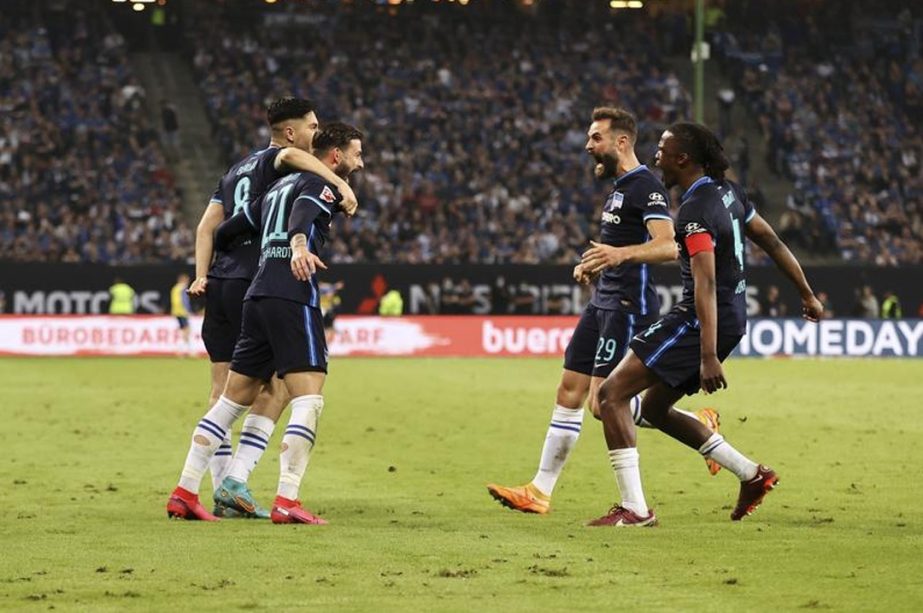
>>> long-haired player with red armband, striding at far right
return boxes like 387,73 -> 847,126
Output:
590,123 -> 823,526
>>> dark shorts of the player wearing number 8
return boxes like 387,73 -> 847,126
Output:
202,277 -> 250,362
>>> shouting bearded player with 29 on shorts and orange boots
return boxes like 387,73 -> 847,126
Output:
487,107 -> 718,513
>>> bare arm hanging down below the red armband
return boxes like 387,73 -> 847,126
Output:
690,251 -> 728,394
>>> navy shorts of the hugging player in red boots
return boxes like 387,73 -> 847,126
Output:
231,298 -> 327,381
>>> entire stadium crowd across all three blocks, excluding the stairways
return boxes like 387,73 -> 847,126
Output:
0,0 -> 923,265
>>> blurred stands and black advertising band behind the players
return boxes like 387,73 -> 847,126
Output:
0,0 -> 923,356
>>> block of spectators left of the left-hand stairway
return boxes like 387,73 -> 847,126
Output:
0,2 -> 194,264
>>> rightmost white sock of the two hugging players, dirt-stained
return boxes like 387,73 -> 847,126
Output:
276,396 -> 324,500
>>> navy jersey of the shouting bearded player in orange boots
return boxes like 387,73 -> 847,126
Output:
591,166 -> 673,315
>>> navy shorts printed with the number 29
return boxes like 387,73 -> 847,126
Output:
564,304 -> 657,378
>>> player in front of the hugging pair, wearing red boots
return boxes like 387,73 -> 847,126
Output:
167,123 -> 363,524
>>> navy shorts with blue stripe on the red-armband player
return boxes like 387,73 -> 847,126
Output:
631,311 -> 743,395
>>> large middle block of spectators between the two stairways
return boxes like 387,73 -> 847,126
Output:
186,5 -> 689,263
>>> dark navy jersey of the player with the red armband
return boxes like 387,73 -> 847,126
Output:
676,177 -> 756,334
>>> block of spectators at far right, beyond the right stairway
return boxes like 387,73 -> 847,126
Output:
714,1 -> 923,266
